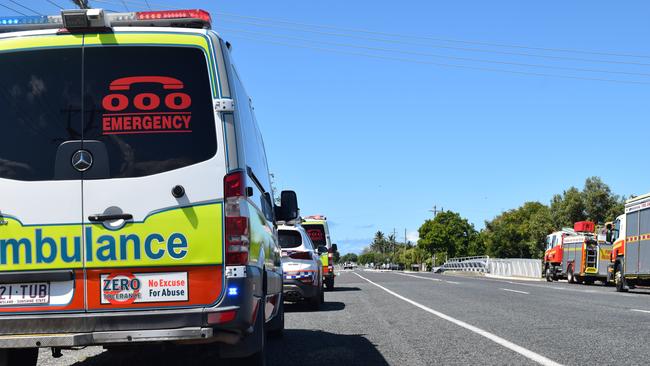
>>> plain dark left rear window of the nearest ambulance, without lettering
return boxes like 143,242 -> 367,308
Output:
0,48 -> 82,181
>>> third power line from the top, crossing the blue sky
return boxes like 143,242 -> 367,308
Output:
221,28 -> 650,77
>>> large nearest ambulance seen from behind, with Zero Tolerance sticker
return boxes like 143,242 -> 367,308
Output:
0,9 -> 297,365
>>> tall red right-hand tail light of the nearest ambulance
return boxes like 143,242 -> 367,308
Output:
223,171 -> 250,266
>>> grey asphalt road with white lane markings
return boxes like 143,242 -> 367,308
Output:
39,271 -> 650,366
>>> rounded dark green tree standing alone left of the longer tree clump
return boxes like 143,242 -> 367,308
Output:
418,211 -> 477,257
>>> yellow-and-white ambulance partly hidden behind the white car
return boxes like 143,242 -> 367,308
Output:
302,215 -> 337,290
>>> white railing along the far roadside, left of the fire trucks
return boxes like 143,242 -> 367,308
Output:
442,256 -> 542,278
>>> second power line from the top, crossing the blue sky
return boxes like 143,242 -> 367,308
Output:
216,19 -> 650,66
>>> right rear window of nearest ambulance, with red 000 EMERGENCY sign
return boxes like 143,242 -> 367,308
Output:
84,46 -> 217,178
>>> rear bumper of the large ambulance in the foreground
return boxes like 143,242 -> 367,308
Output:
0,307 -> 239,348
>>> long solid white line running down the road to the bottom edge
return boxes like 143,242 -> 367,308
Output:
355,273 -> 561,366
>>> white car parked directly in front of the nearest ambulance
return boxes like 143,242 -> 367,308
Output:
278,225 -> 325,310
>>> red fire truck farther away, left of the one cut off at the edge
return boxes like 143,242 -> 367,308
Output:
543,221 -> 612,284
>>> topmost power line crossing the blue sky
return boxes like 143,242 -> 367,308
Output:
215,12 -> 650,58
